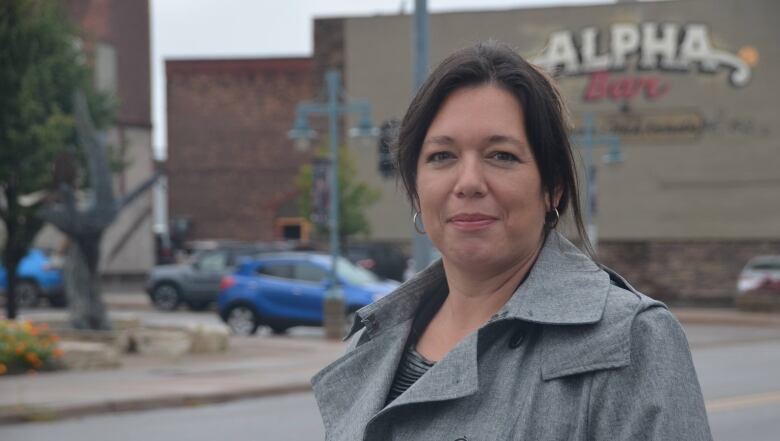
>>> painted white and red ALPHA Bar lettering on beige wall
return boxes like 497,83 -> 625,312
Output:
533,22 -> 758,87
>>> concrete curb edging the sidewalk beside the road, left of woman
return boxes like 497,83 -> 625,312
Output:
0,381 -> 311,425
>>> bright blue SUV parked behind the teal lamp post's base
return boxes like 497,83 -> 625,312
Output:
217,252 -> 399,335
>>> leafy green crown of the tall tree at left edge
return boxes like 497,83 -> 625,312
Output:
0,0 -> 112,194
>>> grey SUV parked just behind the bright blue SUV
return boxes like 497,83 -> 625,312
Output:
146,241 -> 290,311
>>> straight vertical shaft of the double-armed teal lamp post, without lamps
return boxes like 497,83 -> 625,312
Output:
325,70 -> 343,299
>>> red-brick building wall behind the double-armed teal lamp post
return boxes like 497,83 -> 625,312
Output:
166,58 -> 313,241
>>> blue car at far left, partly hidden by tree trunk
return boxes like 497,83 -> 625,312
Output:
0,248 -> 68,308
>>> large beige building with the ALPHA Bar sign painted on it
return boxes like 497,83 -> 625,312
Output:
314,0 -> 780,302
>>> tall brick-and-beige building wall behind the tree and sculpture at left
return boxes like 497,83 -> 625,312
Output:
36,0 -> 154,279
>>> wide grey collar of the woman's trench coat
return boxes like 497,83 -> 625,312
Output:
347,231 -> 610,338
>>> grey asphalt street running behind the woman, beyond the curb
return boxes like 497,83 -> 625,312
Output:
0,322 -> 780,441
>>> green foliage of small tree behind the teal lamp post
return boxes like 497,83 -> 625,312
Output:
296,147 -> 382,239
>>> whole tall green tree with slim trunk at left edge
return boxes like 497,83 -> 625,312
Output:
0,0 -> 113,318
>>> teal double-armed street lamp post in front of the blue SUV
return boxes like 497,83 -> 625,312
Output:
288,69 -> 378,339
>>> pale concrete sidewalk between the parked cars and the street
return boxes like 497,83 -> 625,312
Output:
0,293 -> 780,424
